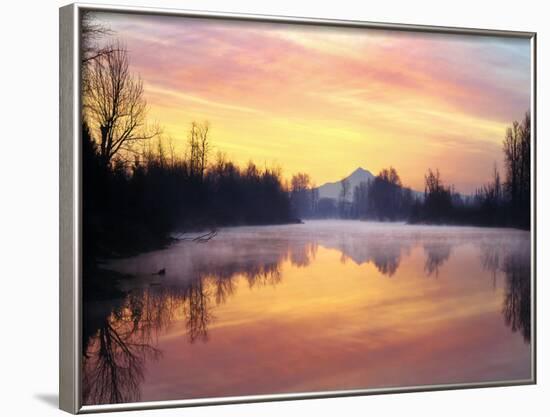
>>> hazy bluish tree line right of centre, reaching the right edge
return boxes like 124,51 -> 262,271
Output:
290,113 -> 531,229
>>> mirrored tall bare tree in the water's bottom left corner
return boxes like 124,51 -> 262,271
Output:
82,291 -> 164,404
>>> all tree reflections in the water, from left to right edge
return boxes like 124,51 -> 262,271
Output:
82,231 -> 531,404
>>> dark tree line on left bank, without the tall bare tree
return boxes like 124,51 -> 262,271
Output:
82,123 -> 292,260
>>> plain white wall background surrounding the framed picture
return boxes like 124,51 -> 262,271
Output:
0,0 -> 550,417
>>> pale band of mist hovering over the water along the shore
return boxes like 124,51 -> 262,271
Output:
104,220 -> 529,284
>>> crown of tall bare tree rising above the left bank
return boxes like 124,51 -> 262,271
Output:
84,43 -> 160,166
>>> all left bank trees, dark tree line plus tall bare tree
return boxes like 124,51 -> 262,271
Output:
82,17 -> 298,266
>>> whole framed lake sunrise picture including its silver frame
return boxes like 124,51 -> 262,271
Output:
60,4 -> 536,413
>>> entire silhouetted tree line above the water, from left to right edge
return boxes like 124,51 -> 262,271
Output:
82,14 -> 530,272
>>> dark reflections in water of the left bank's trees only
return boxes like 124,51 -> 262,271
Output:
82,248 -> 288,404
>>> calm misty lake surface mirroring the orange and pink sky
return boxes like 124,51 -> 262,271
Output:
83,221 -> 531,404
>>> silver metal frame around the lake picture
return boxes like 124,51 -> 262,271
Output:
59,3 -> 537,414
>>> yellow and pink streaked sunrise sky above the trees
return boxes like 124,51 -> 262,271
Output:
91,13 -> 531,193
